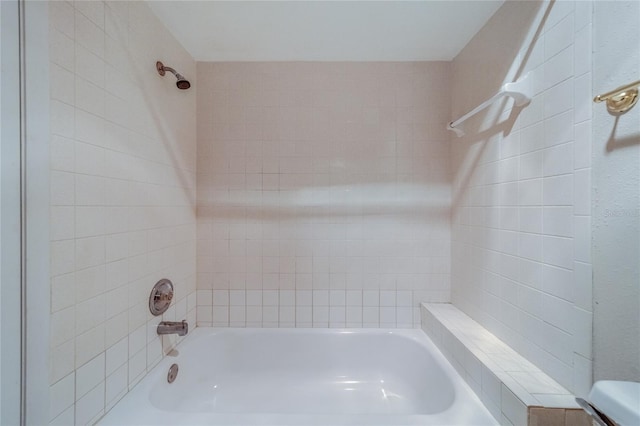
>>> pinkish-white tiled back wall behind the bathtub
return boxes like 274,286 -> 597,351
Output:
197,62 -> 450,327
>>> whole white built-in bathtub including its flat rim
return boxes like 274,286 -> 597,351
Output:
98,328 -> 497,426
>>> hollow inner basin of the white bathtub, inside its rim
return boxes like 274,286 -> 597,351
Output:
149,329 -> 455,415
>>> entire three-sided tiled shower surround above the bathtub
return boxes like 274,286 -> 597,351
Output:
48,1 -> 592,425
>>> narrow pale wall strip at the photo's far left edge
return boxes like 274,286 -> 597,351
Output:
0,1 -> 20,424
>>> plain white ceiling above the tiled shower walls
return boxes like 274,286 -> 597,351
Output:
148,0 -> 504,61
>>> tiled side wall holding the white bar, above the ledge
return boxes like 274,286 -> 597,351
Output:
451,1 -> 592,395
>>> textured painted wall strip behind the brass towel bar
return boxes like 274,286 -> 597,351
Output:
592,1 -> 640,381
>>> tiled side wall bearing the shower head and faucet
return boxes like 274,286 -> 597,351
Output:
49,1 -> 196,425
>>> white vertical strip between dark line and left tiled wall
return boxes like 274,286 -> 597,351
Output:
21,2 -> 51,424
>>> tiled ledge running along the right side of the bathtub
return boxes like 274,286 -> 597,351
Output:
420,303 -> 591,426
